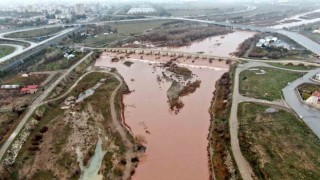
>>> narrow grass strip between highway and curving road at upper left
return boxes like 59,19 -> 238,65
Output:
5,27 -> 64,38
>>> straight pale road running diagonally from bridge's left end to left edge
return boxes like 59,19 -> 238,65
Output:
0,52 -> 93,160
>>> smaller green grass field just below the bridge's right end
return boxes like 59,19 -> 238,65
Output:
240,67 -> 303,101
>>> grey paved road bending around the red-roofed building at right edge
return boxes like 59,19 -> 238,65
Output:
282,68 -> 320,138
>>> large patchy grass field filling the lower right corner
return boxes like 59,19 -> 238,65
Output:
238,103 -> 320,180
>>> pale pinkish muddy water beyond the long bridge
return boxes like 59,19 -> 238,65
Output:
160,31 -> 255,57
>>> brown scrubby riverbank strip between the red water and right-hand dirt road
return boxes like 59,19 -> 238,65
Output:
208,68 -> 240,179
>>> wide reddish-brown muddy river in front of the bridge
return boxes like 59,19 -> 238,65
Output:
95,53 -> 229,180
